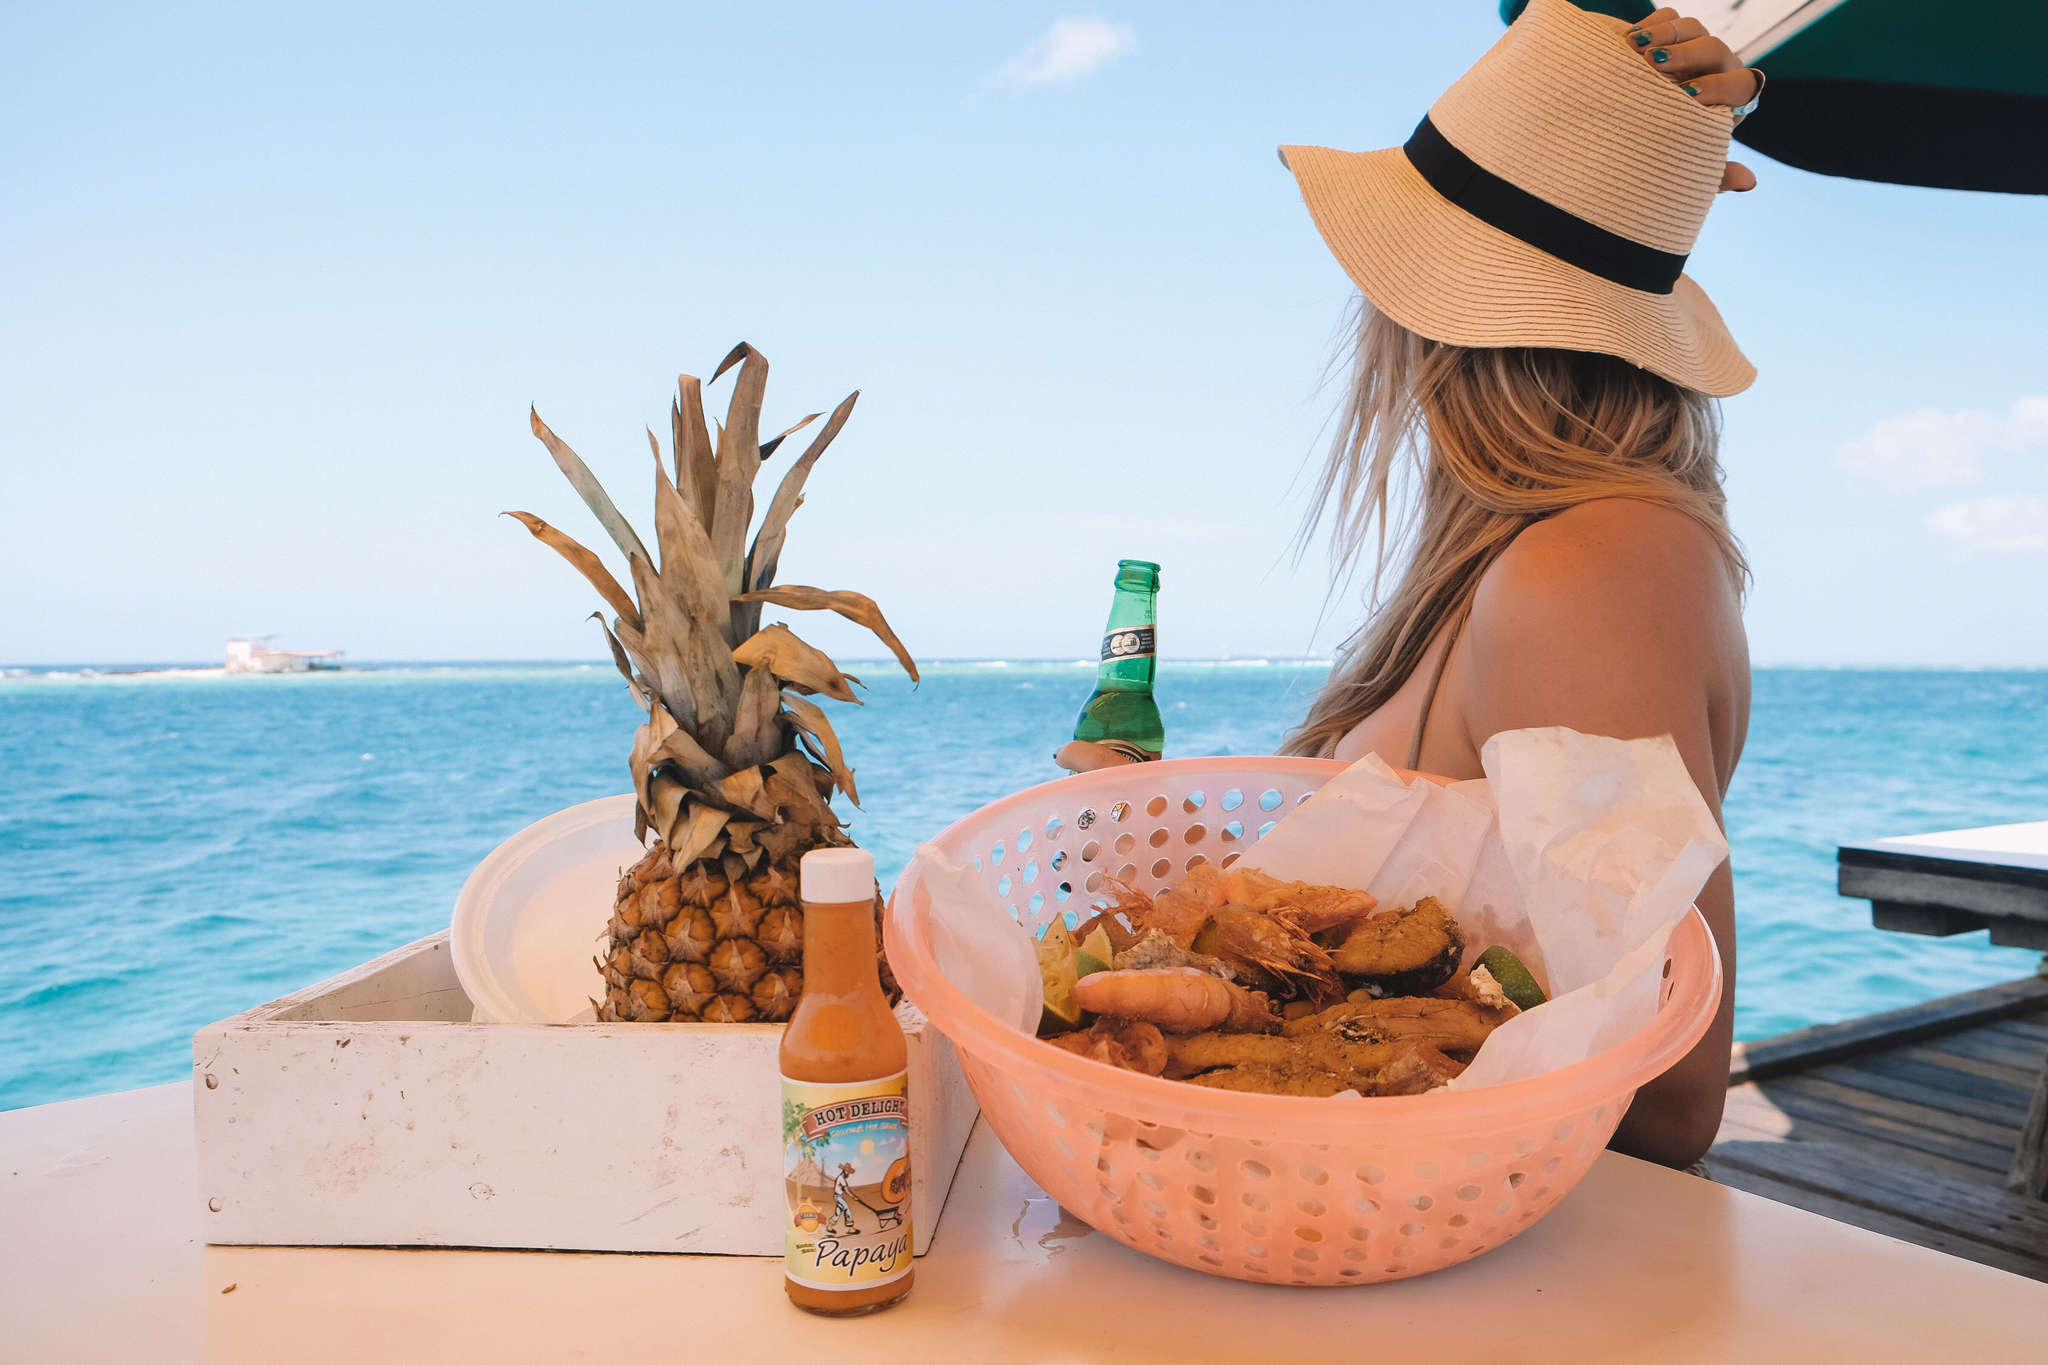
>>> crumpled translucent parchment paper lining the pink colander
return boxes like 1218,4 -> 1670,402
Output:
918,729 -> 1729,1089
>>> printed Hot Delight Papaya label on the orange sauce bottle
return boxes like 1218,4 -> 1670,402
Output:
782,1070 -> 911,1289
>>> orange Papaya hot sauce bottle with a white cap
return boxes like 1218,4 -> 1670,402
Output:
782,849 -> 913,1316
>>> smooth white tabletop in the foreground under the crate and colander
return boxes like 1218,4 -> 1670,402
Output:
0,1085 -> 2048,1365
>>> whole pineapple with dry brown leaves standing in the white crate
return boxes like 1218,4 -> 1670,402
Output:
508,342 -> 918,1023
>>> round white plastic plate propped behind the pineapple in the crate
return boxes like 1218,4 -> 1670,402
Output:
449,792 -> 645,1023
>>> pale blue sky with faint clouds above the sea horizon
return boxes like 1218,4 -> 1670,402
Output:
0,0 -> 2048,665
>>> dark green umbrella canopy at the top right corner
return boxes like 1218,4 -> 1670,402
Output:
1501,0 -> 2048,194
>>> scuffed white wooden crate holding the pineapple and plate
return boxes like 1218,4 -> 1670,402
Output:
193,933 -> 977,1257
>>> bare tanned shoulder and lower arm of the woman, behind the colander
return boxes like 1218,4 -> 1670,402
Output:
1456,501 -> 1749,1166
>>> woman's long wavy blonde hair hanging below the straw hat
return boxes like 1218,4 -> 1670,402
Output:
1282,299 -> 1749,755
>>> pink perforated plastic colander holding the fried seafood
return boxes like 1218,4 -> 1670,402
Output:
887,757 -> 1720,1285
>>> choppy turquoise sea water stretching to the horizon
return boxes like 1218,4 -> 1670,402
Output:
0,661 -> 2048,1107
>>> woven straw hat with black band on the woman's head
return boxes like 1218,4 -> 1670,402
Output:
1280,0 -> 1757,397
